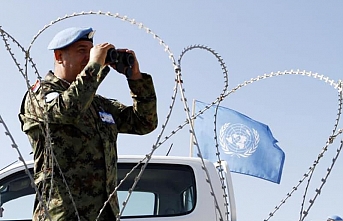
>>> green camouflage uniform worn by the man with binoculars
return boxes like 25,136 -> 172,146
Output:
19,63 -> 157,220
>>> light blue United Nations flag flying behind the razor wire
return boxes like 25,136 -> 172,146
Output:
193,101 -> 285,183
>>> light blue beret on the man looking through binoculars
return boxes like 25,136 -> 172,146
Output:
48,28 -> 95,50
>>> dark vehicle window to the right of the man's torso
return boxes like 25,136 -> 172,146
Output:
118,163 -> 196,218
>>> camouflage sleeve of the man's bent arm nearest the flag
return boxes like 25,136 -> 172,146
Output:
105,73 -> 158,135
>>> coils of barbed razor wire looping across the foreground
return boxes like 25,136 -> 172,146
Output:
0,11 -> 342,220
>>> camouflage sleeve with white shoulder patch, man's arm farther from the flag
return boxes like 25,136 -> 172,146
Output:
20,63 -> 109,131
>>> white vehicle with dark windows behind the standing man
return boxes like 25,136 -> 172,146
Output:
0,156 -> 236,221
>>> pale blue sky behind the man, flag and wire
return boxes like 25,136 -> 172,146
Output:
0,0 -> 343,221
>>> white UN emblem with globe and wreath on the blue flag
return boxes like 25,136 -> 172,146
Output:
219,123 -> 260,157
